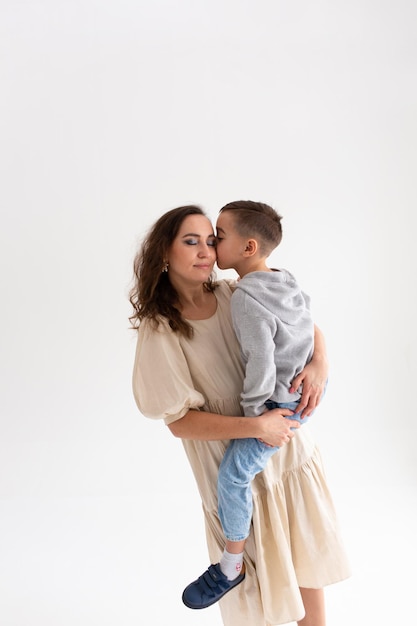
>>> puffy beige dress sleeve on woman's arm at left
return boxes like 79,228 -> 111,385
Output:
132,319 -> 205,424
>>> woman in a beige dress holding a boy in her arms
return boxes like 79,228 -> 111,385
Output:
130,206 -> 349,626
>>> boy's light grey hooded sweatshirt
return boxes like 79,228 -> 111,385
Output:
231,269 -> 314,416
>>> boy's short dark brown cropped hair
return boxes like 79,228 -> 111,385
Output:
220,200 -> 282,255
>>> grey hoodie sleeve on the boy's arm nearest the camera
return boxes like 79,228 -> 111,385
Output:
232,289 -> 277,417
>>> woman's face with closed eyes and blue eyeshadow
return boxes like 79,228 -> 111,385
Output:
167,215 -> 216,284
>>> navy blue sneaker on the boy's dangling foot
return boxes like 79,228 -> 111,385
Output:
182,563 -> 245,609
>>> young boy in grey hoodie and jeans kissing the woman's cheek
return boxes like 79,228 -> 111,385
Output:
183,201 -> 314,608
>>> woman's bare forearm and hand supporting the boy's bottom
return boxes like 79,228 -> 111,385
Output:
168,409 -> 299,447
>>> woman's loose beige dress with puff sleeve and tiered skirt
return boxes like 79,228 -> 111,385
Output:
133,281 -> 350,626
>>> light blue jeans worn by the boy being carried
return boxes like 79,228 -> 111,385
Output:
217,400 -> 308,541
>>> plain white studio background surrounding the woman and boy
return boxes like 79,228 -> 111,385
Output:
0,0 -> 417,626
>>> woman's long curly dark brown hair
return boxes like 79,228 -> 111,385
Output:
129,204 -> 216,337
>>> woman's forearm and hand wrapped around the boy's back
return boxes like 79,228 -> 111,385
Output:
290,325 -> 329,417
